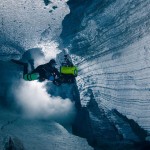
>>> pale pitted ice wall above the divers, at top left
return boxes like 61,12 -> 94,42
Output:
0,0 -> 69,61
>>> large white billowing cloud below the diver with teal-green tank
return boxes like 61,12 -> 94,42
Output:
14,81 -> 75,123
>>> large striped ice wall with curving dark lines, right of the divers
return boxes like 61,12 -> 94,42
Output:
61,0 -> 150,132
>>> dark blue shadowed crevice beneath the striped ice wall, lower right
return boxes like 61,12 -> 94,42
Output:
72,82 -> 150,150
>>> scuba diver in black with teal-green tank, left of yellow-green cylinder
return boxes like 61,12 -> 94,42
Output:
11,59 -> 60,84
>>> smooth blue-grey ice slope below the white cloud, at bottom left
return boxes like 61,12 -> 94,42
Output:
0,110 -> 92,150
